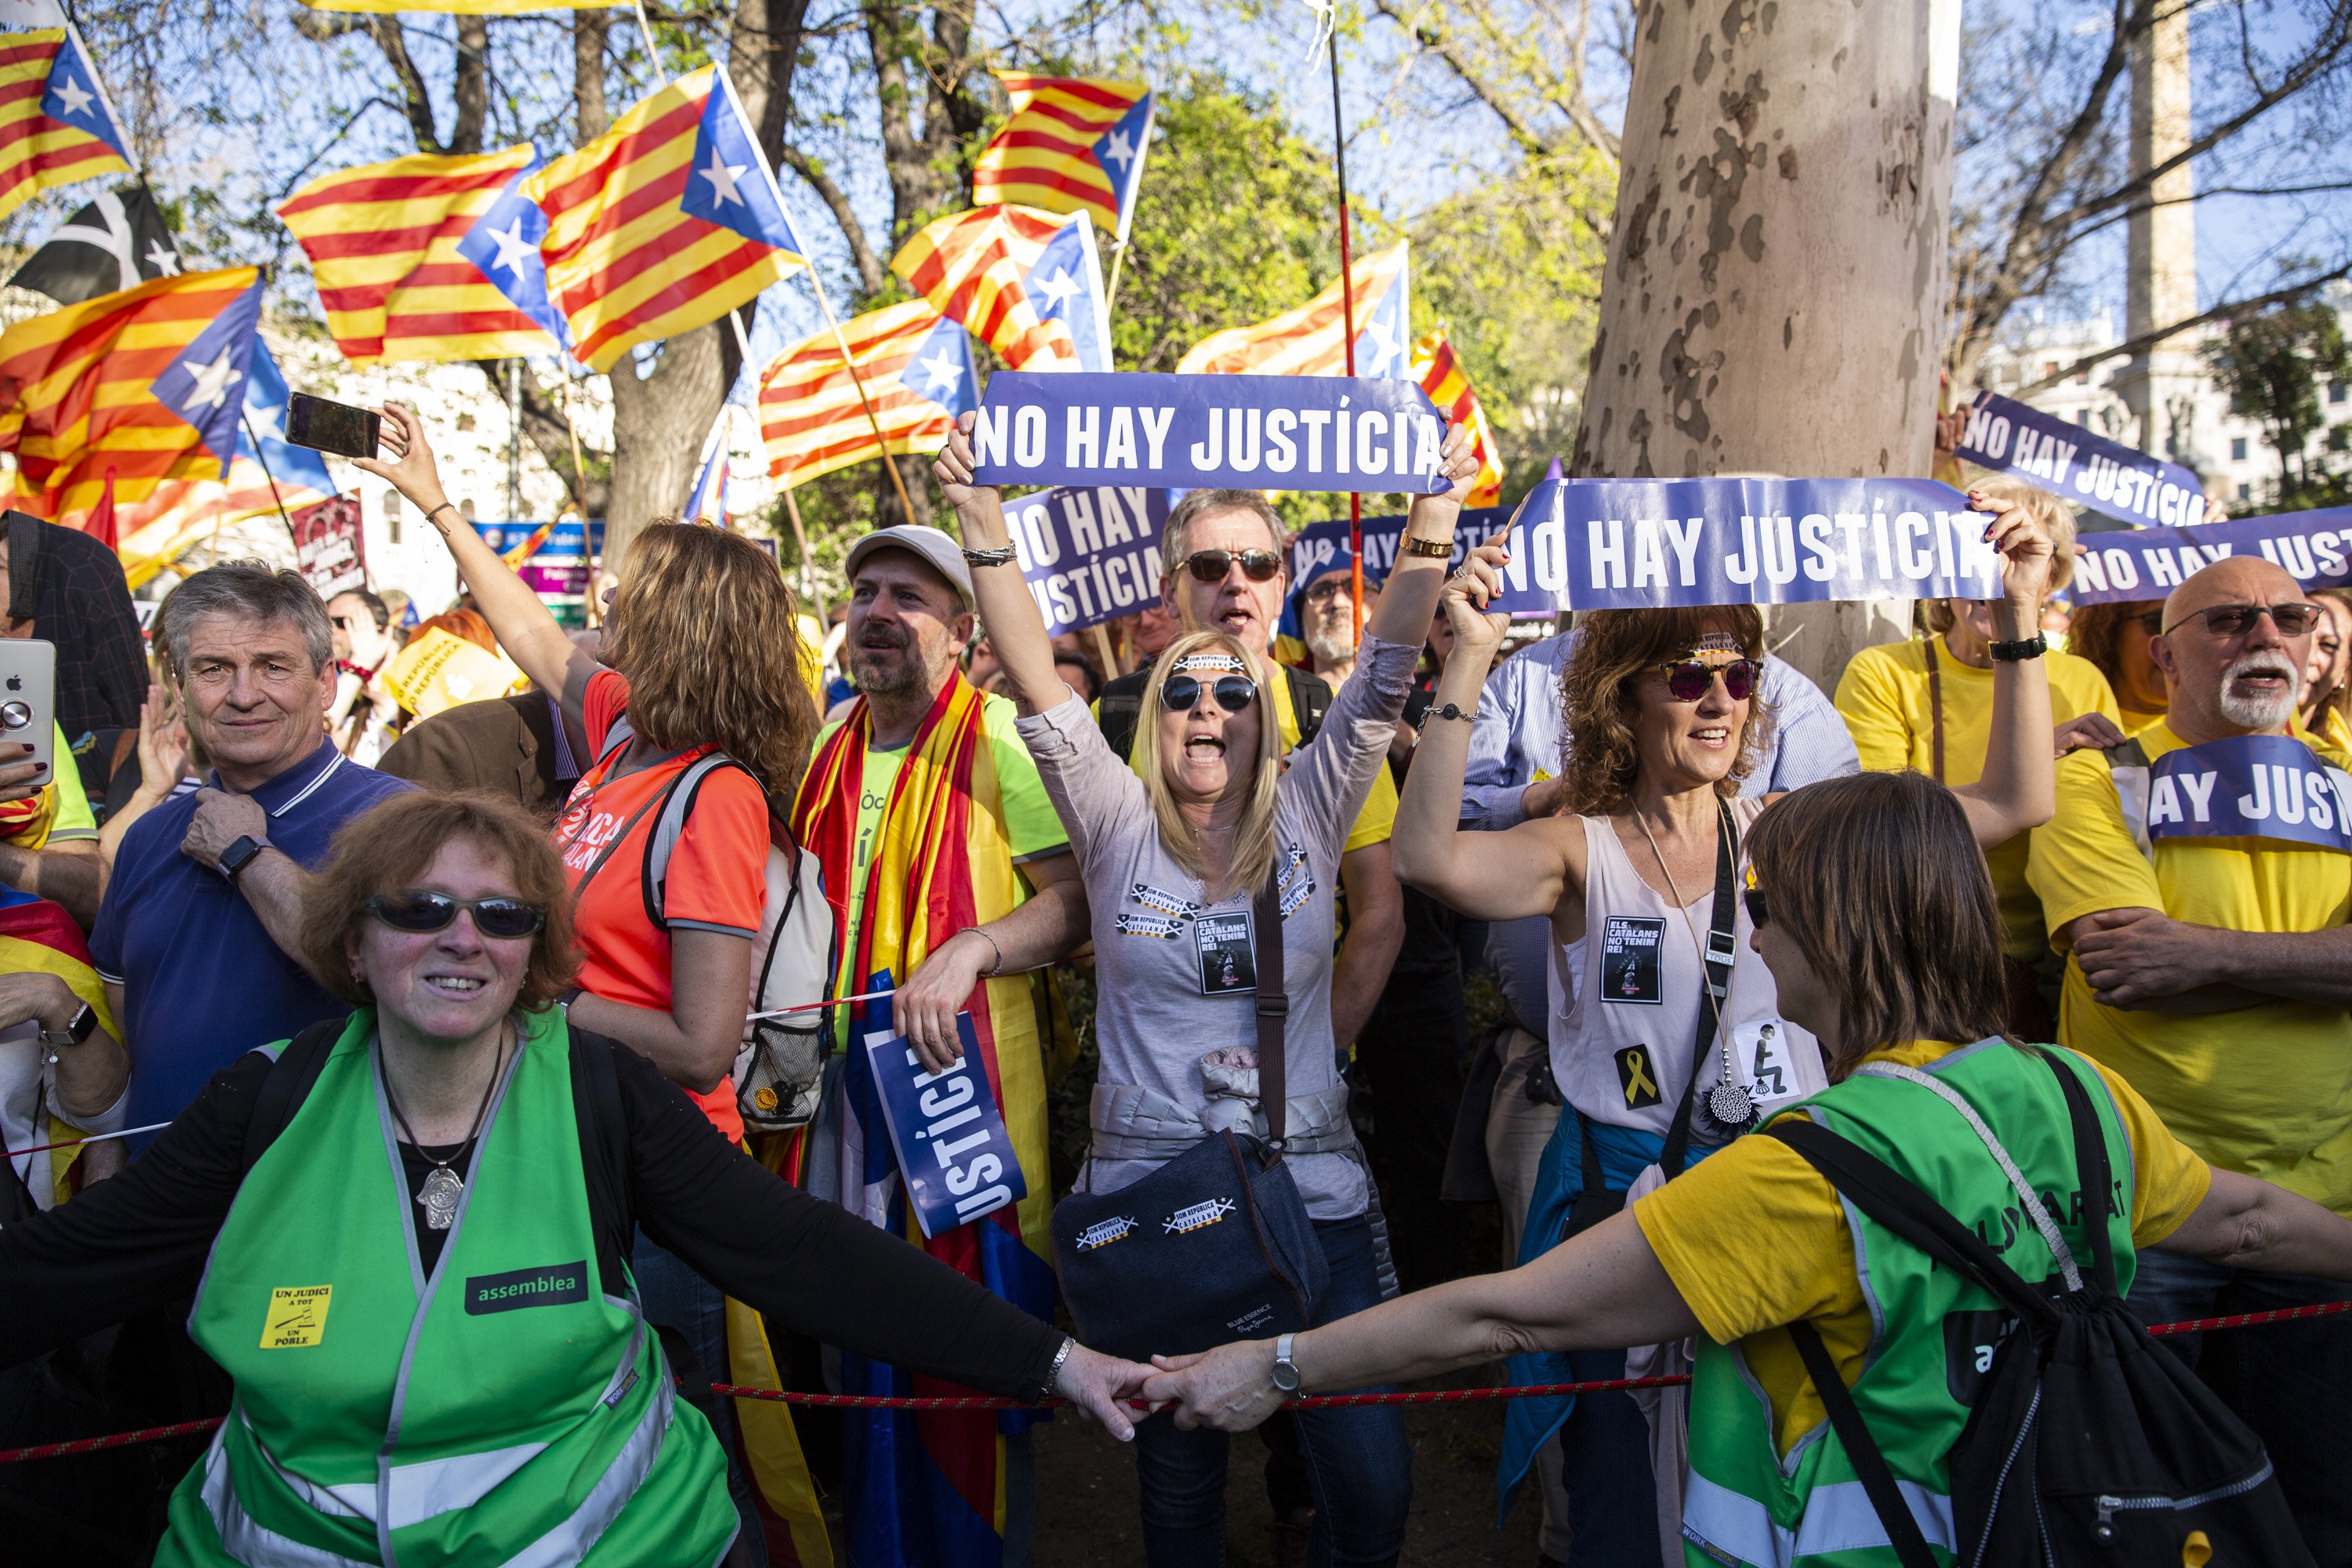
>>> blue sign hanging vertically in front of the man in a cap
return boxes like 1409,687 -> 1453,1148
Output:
866,1013 -> 1028,1236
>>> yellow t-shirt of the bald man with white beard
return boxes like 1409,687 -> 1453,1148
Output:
2027,724 -> 2352,1215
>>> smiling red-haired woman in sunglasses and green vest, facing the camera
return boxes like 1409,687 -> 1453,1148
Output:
0,794 -> 1150,1568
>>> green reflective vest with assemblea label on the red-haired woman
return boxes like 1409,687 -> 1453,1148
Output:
155,1008 -> 736,1568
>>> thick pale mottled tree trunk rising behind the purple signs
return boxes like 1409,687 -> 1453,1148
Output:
1571,0 -> 1959,689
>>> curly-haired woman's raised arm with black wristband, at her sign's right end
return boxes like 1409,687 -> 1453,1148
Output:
1952,492 -> 2058,848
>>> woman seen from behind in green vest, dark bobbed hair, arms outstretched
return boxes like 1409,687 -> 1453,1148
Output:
1143,774 -> 2352,1568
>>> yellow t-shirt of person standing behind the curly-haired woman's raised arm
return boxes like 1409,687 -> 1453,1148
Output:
1837,637 -> 2122,964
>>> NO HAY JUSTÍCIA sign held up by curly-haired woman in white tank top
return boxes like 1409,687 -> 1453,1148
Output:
1489,480 -> 2002,614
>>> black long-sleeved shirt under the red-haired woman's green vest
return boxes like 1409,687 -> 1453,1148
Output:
0,1029 -> 1061,1394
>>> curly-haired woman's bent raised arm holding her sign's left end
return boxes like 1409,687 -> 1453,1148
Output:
1383,543 -> 1583,919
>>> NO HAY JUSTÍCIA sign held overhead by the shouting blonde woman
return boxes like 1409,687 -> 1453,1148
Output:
971,372 -> 1446,494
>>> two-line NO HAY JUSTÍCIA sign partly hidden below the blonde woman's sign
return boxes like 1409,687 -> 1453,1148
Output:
1004,485 -> 1169,637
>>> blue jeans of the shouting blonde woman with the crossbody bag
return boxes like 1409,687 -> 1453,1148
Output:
1136,1220 -> 1414,1568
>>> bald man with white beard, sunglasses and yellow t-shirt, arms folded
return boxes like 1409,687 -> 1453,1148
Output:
2027,555 -> 2352,1563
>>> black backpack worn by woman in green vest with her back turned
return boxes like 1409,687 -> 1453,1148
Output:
1764,1046 -> 2312,1568
